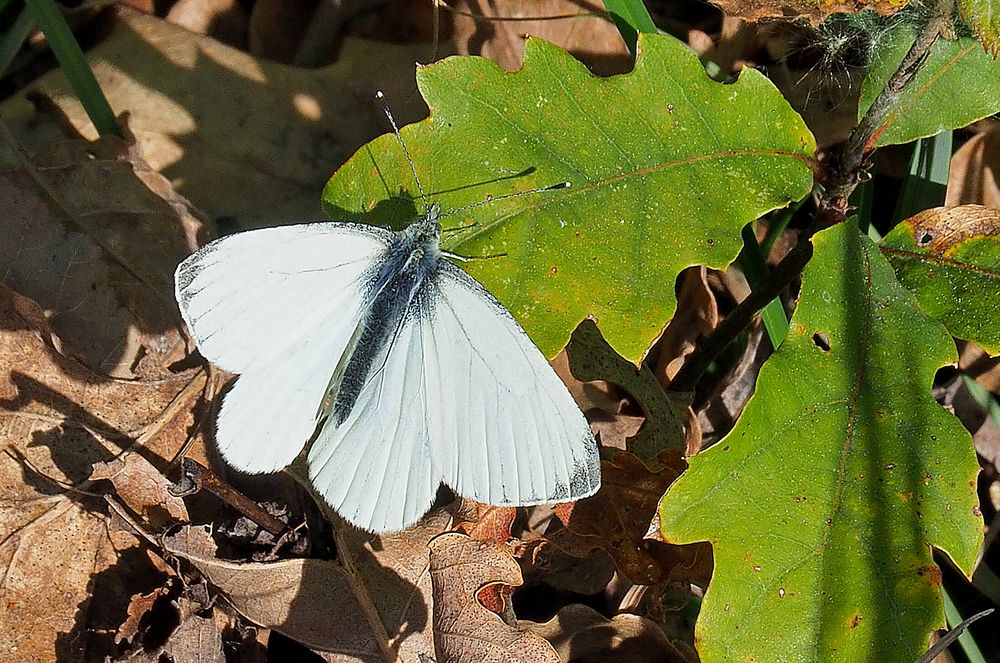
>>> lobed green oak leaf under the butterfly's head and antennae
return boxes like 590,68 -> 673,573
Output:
323,34 -> 815,361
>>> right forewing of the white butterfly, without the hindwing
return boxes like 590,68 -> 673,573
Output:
424,262 -> 600,506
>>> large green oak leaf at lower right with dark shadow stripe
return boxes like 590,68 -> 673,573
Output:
659,223 -> 983,663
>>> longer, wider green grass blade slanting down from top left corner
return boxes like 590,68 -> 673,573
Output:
25,0 -> 121,136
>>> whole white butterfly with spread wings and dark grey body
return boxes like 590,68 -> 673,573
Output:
175,198 -> 600,532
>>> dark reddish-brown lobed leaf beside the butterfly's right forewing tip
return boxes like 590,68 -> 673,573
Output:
547,450 -> 707,585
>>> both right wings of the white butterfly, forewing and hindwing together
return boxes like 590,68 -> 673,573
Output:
309,260 -> 600,531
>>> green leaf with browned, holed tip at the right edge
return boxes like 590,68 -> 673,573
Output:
880,205 -> 1000,355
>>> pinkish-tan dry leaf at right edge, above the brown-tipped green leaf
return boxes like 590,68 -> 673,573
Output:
944,122 -> 1000,209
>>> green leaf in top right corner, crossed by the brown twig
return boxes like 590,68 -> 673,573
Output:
858,23 -> 1000,150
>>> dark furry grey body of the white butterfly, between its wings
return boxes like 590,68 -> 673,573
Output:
328,204 -> 442,426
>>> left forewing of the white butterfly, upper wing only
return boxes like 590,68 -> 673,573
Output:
175,223 -> 392,377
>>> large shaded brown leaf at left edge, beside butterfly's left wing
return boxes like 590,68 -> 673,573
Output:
0,128 -> 200,378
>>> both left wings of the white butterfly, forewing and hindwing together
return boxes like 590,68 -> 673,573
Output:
176,223 -> 392,472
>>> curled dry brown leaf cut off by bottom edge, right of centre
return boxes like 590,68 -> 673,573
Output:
522,603 -> 689,663
